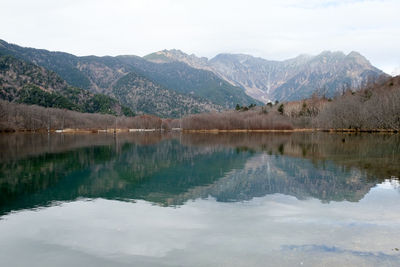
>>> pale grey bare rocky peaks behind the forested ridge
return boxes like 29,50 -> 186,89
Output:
145,50 -> 385,102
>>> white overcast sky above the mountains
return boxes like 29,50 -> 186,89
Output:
0,0 -> 400,73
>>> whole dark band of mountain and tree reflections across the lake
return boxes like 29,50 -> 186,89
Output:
0,133 -> 400,217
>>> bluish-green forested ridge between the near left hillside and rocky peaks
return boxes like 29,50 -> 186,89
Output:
0,41 -> 261,117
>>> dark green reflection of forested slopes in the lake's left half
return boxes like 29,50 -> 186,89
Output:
0,135 -> 248,216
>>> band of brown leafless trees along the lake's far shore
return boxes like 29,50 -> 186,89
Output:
0,76 -> 400,132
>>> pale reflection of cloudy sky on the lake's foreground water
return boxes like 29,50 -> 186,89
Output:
0,182 -> 400,266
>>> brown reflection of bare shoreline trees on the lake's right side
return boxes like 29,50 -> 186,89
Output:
183,132 -> 400,179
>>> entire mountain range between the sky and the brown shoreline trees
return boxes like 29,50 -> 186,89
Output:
0,40 -> 386,117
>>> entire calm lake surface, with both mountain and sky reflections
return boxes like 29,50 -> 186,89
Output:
0,133 -> 400,266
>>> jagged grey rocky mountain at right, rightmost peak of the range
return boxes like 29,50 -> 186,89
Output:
272,52 -> 385,101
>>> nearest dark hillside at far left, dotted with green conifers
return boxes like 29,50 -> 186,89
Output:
0,56 -> 133,115
